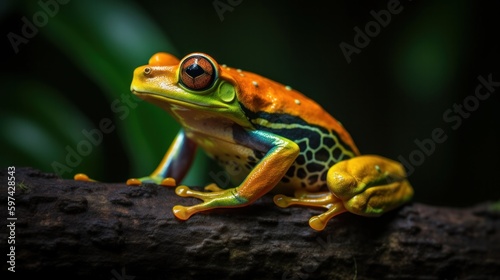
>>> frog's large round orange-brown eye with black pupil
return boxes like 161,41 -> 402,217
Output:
180,55 -> 216,91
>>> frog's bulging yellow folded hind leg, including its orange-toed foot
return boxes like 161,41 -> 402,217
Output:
274,155 -> 413,230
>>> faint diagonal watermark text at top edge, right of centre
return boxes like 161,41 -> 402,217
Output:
339,0 -> 411,64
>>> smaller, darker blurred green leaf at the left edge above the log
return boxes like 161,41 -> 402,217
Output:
0,76 -> 103,176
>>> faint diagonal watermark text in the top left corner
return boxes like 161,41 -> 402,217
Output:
7,0 -> 70,54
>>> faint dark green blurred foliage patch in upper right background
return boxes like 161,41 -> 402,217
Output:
394,1 -> 469,100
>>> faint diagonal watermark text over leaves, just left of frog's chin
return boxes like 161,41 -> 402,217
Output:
51,93 -> 142,177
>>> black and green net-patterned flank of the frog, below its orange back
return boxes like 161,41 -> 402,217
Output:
242,106 -> 355,188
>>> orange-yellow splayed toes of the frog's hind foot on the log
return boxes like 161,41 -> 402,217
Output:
274,191 -> 347,231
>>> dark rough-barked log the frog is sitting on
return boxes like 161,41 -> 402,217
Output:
0,168 -> 500,280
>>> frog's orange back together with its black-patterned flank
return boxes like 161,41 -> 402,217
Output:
216,65 -> 359,193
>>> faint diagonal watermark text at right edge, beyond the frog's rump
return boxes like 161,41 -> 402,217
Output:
398,73 -> 500,176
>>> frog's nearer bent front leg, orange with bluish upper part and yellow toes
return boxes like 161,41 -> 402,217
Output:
173,131 -> 299,220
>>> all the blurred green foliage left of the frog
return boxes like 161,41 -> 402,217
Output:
2,1 -> 207,186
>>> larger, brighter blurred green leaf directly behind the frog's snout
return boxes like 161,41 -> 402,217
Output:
18,0 -> 205,180
